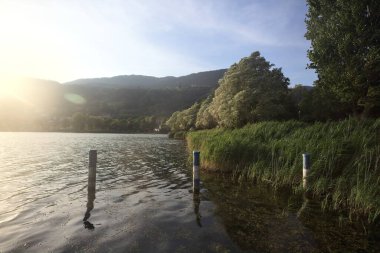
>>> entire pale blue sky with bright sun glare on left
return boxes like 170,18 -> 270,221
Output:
0,0 -> 316,85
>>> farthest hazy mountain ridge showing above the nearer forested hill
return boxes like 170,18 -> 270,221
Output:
64,69 -> 226,89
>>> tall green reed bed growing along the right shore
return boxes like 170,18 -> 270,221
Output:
187,119 -> 380,221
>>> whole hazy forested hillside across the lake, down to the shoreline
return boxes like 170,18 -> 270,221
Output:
0,69 -> 225,132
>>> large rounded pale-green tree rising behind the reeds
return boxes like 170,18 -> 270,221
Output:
209,52 -> 289,127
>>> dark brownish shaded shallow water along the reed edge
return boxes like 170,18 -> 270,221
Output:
203,173 -> 380,252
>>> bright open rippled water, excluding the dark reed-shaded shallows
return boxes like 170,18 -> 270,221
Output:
0,133 -> 239,252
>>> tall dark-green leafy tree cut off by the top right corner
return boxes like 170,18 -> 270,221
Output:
305,0 -> 380,116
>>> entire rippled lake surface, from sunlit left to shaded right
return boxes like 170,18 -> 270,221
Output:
0,133 -> 380,252
